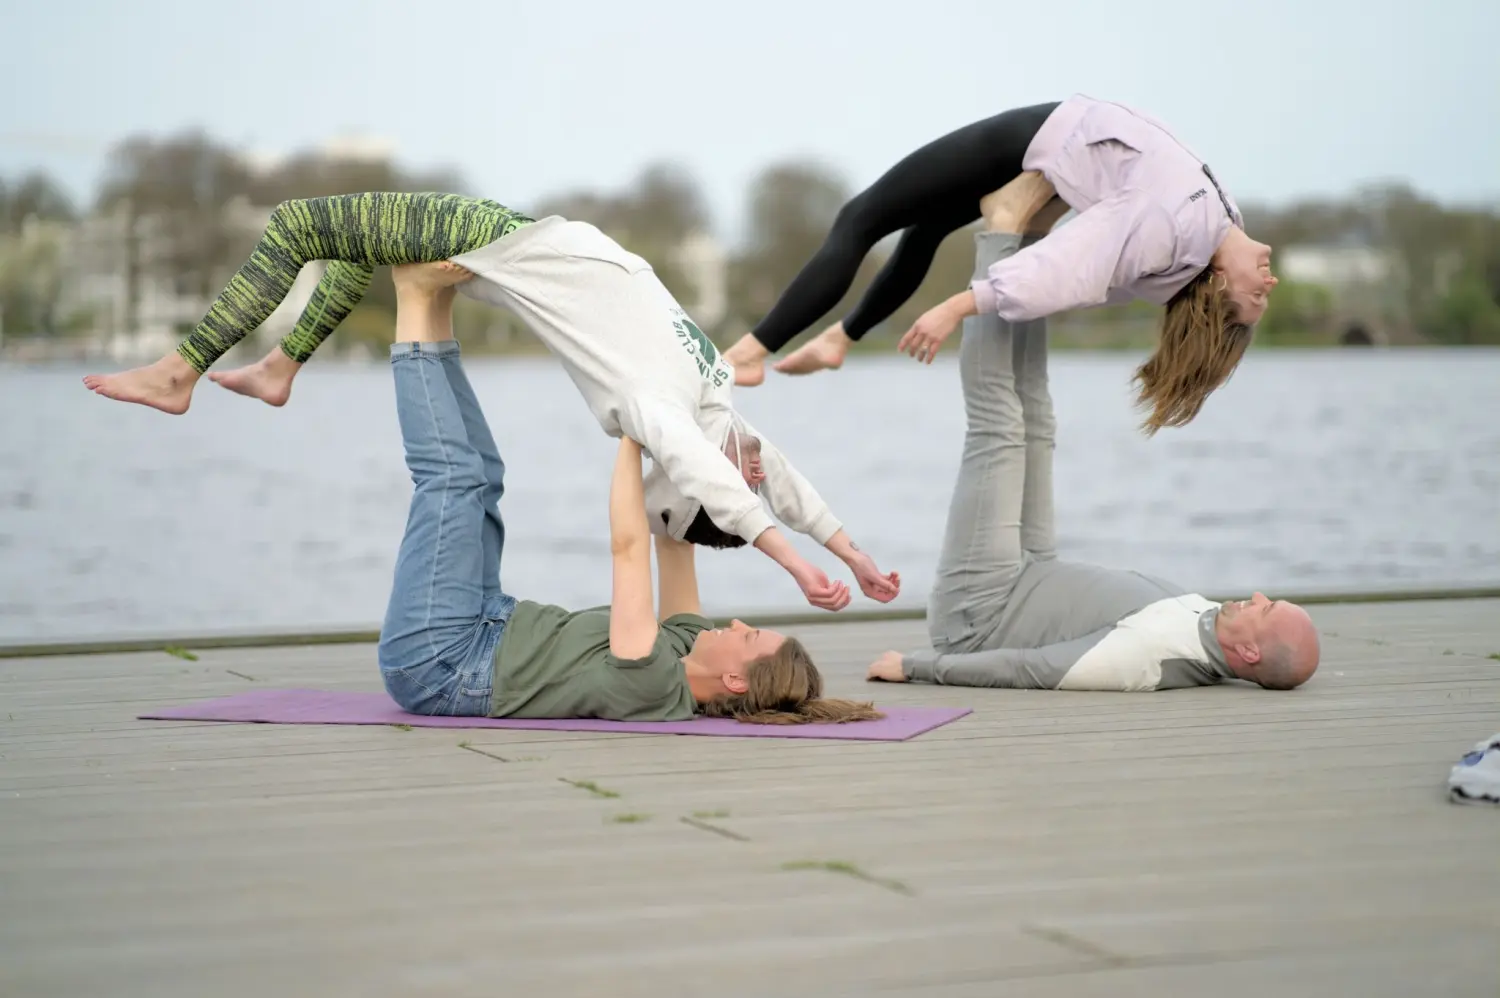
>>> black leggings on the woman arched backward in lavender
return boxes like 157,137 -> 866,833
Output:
755,104 -> 1058,353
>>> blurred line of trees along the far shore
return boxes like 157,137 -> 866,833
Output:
0,132 -> 1500,348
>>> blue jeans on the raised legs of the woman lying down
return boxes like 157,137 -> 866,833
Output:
380,341 -> 516,717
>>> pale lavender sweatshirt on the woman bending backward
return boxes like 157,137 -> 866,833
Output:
971,95 -> 1242,323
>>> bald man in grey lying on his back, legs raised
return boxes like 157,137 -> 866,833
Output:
869,225 -> 1319,692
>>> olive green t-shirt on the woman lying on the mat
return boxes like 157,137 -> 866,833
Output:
489,602 -> 714,720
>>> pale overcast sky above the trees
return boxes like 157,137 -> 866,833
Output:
0,0 -> 1500,236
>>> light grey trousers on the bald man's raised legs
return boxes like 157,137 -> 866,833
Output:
927,233 -> 1058,653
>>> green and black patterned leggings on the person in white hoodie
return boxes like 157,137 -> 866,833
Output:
177,192 -> 533,374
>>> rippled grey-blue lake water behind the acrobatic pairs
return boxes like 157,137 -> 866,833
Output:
0,350 -> 1500,641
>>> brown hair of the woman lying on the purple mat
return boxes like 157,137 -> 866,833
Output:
704,638 -> 885,725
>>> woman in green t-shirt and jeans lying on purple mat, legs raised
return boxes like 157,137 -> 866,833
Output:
380,264 -> 882,723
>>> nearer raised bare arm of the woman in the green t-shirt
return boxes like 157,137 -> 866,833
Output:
609,437 -> 657,660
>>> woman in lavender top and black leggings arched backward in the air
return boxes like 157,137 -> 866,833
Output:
725,96 -> 1277,432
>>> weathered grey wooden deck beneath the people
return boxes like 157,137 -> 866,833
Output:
0,600 -> 1500,998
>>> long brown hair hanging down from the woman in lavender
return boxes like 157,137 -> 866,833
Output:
1136,267 -> 1254,437
